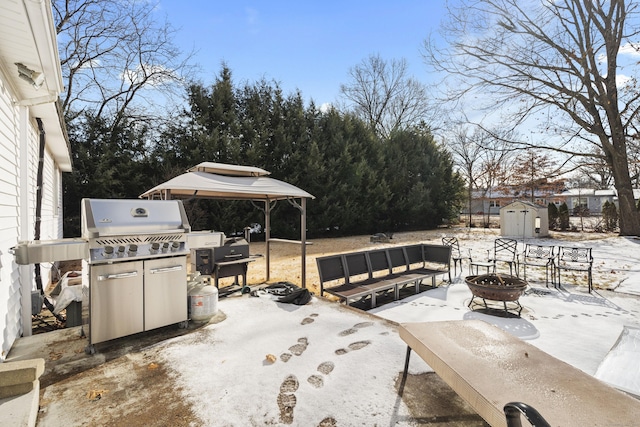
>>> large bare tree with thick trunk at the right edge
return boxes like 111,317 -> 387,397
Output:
424,0 -> 640,235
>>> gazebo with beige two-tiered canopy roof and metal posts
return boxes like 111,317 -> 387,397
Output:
140,162 -> 315,287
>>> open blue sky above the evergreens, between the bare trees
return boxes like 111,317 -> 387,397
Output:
159,0 -> 445,106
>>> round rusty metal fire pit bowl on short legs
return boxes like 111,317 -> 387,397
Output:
465,273 -> 528,316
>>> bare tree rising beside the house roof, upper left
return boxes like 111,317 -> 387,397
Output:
53,0 -> 192,126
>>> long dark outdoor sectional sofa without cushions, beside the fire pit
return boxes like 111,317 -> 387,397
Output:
316,244 -> 451,308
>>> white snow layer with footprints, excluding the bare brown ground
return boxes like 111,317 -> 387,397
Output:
37,229 -> 640,426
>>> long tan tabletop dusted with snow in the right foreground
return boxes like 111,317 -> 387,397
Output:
399,320 -> 640,426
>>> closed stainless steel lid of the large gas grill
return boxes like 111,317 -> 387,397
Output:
81,199 -> 191,239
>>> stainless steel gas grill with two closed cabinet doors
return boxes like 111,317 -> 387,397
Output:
82,199 -> 191,353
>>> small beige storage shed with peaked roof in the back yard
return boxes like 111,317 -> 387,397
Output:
500,200 -> 549,238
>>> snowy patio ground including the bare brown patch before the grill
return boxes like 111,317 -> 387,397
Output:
10,230 -> 640,426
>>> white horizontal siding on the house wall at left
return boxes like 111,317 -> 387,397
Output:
0,76 -> 62,361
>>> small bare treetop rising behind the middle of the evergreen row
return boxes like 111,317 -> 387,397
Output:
340,55 -> 433,139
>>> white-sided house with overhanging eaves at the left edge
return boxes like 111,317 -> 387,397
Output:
0,0 -> 71,361
